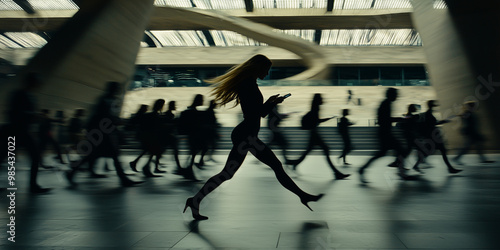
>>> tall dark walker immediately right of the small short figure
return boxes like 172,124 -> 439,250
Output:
358,88 -> 411,183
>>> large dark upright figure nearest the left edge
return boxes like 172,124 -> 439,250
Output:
1,73 -> 50,193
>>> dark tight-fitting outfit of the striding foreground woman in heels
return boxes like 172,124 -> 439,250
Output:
193,79 -> 309,205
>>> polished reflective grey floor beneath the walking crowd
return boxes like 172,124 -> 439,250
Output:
0,151 -> 500,250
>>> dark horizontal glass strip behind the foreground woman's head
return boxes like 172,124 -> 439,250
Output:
130,65 -> 429,89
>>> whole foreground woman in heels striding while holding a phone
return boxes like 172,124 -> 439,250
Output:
184,55 -> 323,220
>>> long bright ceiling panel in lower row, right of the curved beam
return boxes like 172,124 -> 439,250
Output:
320,29 -> 422,46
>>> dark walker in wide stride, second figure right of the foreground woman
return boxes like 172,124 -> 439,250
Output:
287,94 -> 349,180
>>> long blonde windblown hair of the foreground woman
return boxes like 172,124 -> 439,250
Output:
205,54 -> 272,106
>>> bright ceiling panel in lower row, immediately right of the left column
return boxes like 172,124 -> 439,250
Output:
151,30 -> 209,47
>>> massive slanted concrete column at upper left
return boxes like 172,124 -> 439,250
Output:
0,0 -> 154,121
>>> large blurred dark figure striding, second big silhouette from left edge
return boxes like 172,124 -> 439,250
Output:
66,82 -> 142,187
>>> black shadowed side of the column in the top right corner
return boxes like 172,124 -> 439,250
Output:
446,0 -> 500,149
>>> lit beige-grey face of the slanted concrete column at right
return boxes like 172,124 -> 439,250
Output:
412,0 -> 500,149
